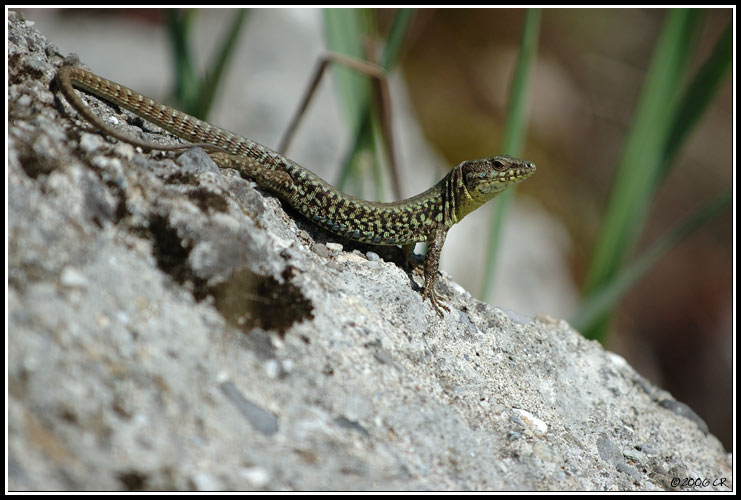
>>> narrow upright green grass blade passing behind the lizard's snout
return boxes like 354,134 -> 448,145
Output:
481,9 -> 541,299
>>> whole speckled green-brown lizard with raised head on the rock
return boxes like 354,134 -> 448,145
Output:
56,64 -> 535,318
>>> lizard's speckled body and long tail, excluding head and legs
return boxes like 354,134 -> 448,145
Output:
58,66 -> 455,245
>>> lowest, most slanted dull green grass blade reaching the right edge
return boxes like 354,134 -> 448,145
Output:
570,189 -> 733,331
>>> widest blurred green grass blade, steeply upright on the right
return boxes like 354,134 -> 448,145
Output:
582,9 -> 700,339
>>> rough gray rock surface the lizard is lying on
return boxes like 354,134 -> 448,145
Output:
6,12 -> 732,491
